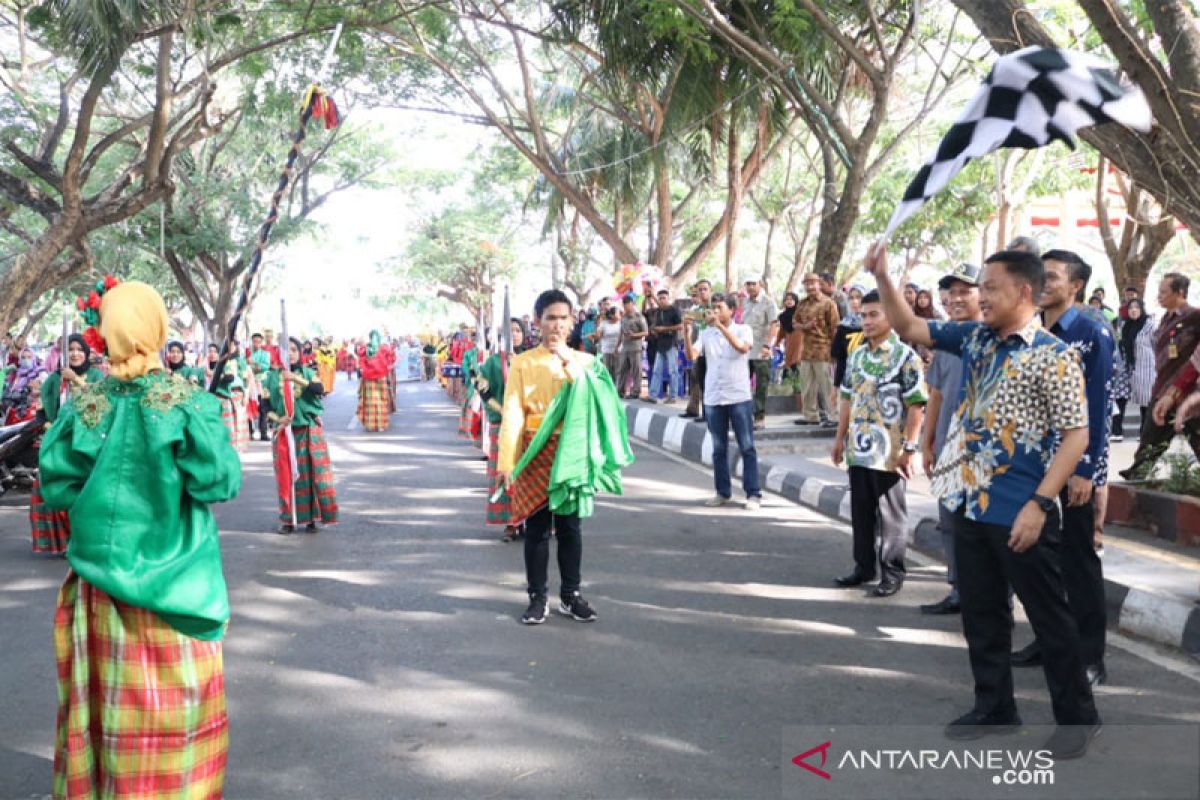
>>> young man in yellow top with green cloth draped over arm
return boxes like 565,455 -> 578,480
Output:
497,289 -> 634,625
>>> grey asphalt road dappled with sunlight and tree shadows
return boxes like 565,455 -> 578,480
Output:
0,383 -> 1200,800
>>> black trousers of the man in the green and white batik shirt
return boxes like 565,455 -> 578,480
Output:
850,467 -> 908,583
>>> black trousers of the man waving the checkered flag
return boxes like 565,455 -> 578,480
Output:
954,510 -> 1099,724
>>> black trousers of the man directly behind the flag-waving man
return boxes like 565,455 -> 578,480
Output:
1061,491 -> 1109,667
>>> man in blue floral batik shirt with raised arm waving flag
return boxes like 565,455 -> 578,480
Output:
865,247 -> 1106,760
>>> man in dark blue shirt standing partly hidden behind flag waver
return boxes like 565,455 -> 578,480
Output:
1013,249 -> 1115,686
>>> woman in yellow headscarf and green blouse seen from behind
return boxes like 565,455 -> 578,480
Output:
41,282 -> 241,798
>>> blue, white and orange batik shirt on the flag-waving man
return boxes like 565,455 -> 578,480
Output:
929,317 -> 1087,528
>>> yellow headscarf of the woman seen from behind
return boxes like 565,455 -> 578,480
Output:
100,281 -> 168,380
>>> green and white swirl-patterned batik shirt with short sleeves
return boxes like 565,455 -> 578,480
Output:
841,332 -> 928,473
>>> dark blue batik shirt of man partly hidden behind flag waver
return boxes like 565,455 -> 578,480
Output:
1050,306 -> 1116,486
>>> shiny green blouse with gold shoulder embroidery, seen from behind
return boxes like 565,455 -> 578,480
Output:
41,371 -> 241,639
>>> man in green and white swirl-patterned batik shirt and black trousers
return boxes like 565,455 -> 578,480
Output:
832,291 -> 926,597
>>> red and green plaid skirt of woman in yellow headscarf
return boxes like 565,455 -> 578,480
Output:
54,572 -> 229,800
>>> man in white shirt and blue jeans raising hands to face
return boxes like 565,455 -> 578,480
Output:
683,295 -> 762,511
